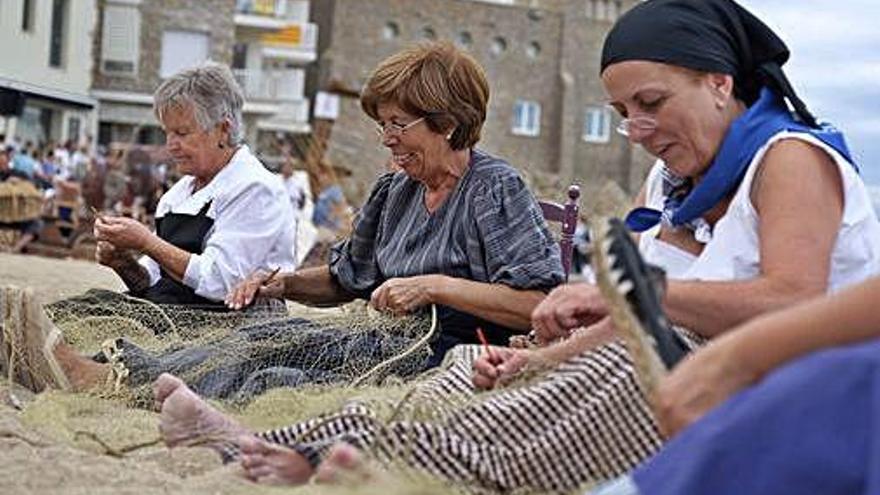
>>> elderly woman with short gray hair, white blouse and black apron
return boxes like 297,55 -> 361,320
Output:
95,62 -> 296,309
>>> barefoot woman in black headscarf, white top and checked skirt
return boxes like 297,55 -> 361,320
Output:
156,0 -> 880,492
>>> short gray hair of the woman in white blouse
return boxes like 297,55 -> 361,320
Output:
153,61 -> 244,146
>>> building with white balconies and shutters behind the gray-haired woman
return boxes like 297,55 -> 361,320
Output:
92,0 -> 317,155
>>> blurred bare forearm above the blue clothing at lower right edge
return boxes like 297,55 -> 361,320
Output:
716,277 -> 880,376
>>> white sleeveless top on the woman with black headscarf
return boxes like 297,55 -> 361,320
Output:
639,131 -> 880,292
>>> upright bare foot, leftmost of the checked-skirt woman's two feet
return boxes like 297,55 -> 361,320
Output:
153,373 -> 251,454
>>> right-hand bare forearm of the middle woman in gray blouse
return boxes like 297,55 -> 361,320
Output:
432,277 -> 546,331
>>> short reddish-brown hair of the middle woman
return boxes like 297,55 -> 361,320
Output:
361,41 -> 489,150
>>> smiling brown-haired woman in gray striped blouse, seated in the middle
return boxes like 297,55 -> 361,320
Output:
6,43 -> 563,397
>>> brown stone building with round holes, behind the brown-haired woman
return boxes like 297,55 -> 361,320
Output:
309,0 -> 651,202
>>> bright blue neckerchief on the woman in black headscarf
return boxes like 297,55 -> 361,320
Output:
626,87 -> 858,232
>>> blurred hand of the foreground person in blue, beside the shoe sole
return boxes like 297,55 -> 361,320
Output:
654,339 -> 758,438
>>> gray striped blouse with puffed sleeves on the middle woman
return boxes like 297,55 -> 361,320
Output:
330,150 -> 564,357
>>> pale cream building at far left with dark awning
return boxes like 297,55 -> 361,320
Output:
0,0 -> 97,143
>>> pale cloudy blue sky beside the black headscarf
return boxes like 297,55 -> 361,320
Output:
739,0 -> 880,186
